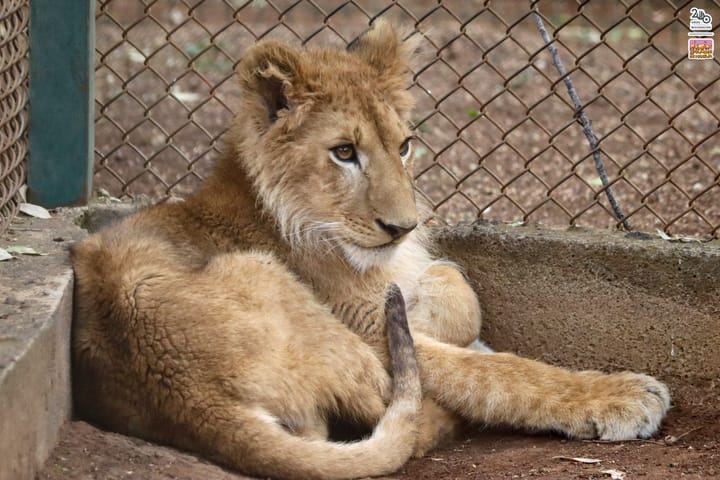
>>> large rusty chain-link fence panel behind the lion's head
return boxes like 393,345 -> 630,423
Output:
95,0 -> 720,238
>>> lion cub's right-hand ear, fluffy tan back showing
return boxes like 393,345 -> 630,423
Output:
347,19 -> 418,77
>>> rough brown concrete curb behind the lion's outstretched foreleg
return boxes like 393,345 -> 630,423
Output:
436,222 -> 720,409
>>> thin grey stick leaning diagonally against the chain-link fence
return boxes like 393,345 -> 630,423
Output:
534,5 -> 632,230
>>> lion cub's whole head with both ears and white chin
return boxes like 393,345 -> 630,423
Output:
232,22 -> 418,269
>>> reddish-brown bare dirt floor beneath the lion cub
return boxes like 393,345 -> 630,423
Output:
36,407 -> 720,480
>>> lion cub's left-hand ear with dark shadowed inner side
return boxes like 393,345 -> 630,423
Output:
237,41 -> 304,123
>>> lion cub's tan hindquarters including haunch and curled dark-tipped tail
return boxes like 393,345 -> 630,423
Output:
75,246 -> 421,478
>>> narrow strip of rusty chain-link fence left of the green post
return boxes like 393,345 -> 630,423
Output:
0,0 -> 29,233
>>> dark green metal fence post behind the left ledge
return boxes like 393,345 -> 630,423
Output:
28,0 -> 95,207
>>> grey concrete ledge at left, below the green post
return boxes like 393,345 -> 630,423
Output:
0,214 -> 83,480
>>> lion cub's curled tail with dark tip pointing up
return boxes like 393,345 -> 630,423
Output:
205,285 -> 421,479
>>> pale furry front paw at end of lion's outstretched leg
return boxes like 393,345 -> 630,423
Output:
571,372 -> 670,440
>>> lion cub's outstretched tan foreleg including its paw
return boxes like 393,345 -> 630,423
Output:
415,334 -> 670,440
